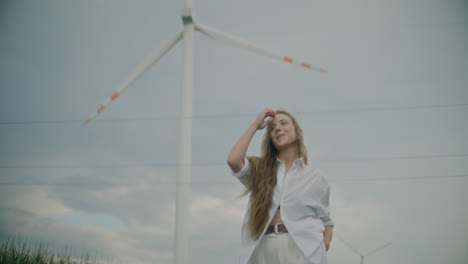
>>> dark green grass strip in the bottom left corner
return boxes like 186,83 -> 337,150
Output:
0,240 -> 112,264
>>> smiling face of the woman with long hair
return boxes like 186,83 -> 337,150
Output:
270,114 -> 297,150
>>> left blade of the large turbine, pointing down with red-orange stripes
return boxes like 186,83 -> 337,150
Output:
83,31 -> 183,125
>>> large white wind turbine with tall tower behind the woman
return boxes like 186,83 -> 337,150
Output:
84,0 -> 327,264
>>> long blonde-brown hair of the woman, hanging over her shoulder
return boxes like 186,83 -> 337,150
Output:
244,110 -> 307,240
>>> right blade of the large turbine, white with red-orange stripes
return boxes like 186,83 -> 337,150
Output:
195,23 -> 327,73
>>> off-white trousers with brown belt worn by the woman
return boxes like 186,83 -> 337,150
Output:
251,233 -> 305,264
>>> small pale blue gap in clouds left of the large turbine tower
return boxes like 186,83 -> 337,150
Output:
54,211 -> 122,229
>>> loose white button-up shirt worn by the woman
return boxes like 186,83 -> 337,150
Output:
232,158 -> 334,264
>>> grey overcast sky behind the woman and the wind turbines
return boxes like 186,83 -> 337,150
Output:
0,0 -> 468,264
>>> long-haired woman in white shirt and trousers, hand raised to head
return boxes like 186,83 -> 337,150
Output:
227,108 -> 334,264
